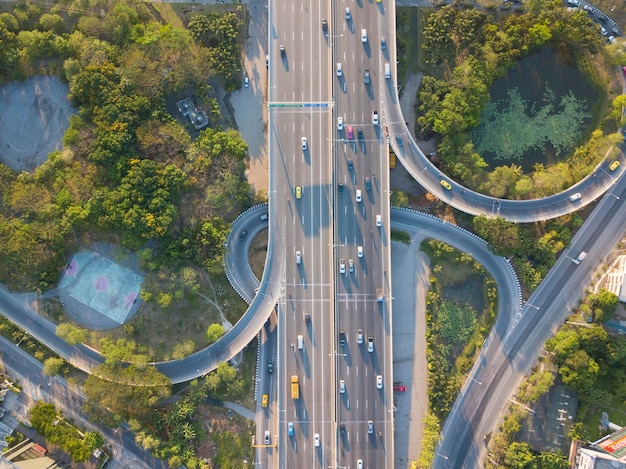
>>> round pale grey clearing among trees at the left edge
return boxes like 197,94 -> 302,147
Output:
0,76 -> 75,171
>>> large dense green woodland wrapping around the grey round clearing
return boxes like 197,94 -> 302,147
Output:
0,0 -> 251,290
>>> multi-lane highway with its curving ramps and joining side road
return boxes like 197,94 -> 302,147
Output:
0,0 -> 626,468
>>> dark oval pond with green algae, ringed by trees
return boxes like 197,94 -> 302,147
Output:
471,48 -> 599,172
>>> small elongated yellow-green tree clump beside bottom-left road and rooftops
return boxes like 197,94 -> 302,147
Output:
30,402 -> 104,462
